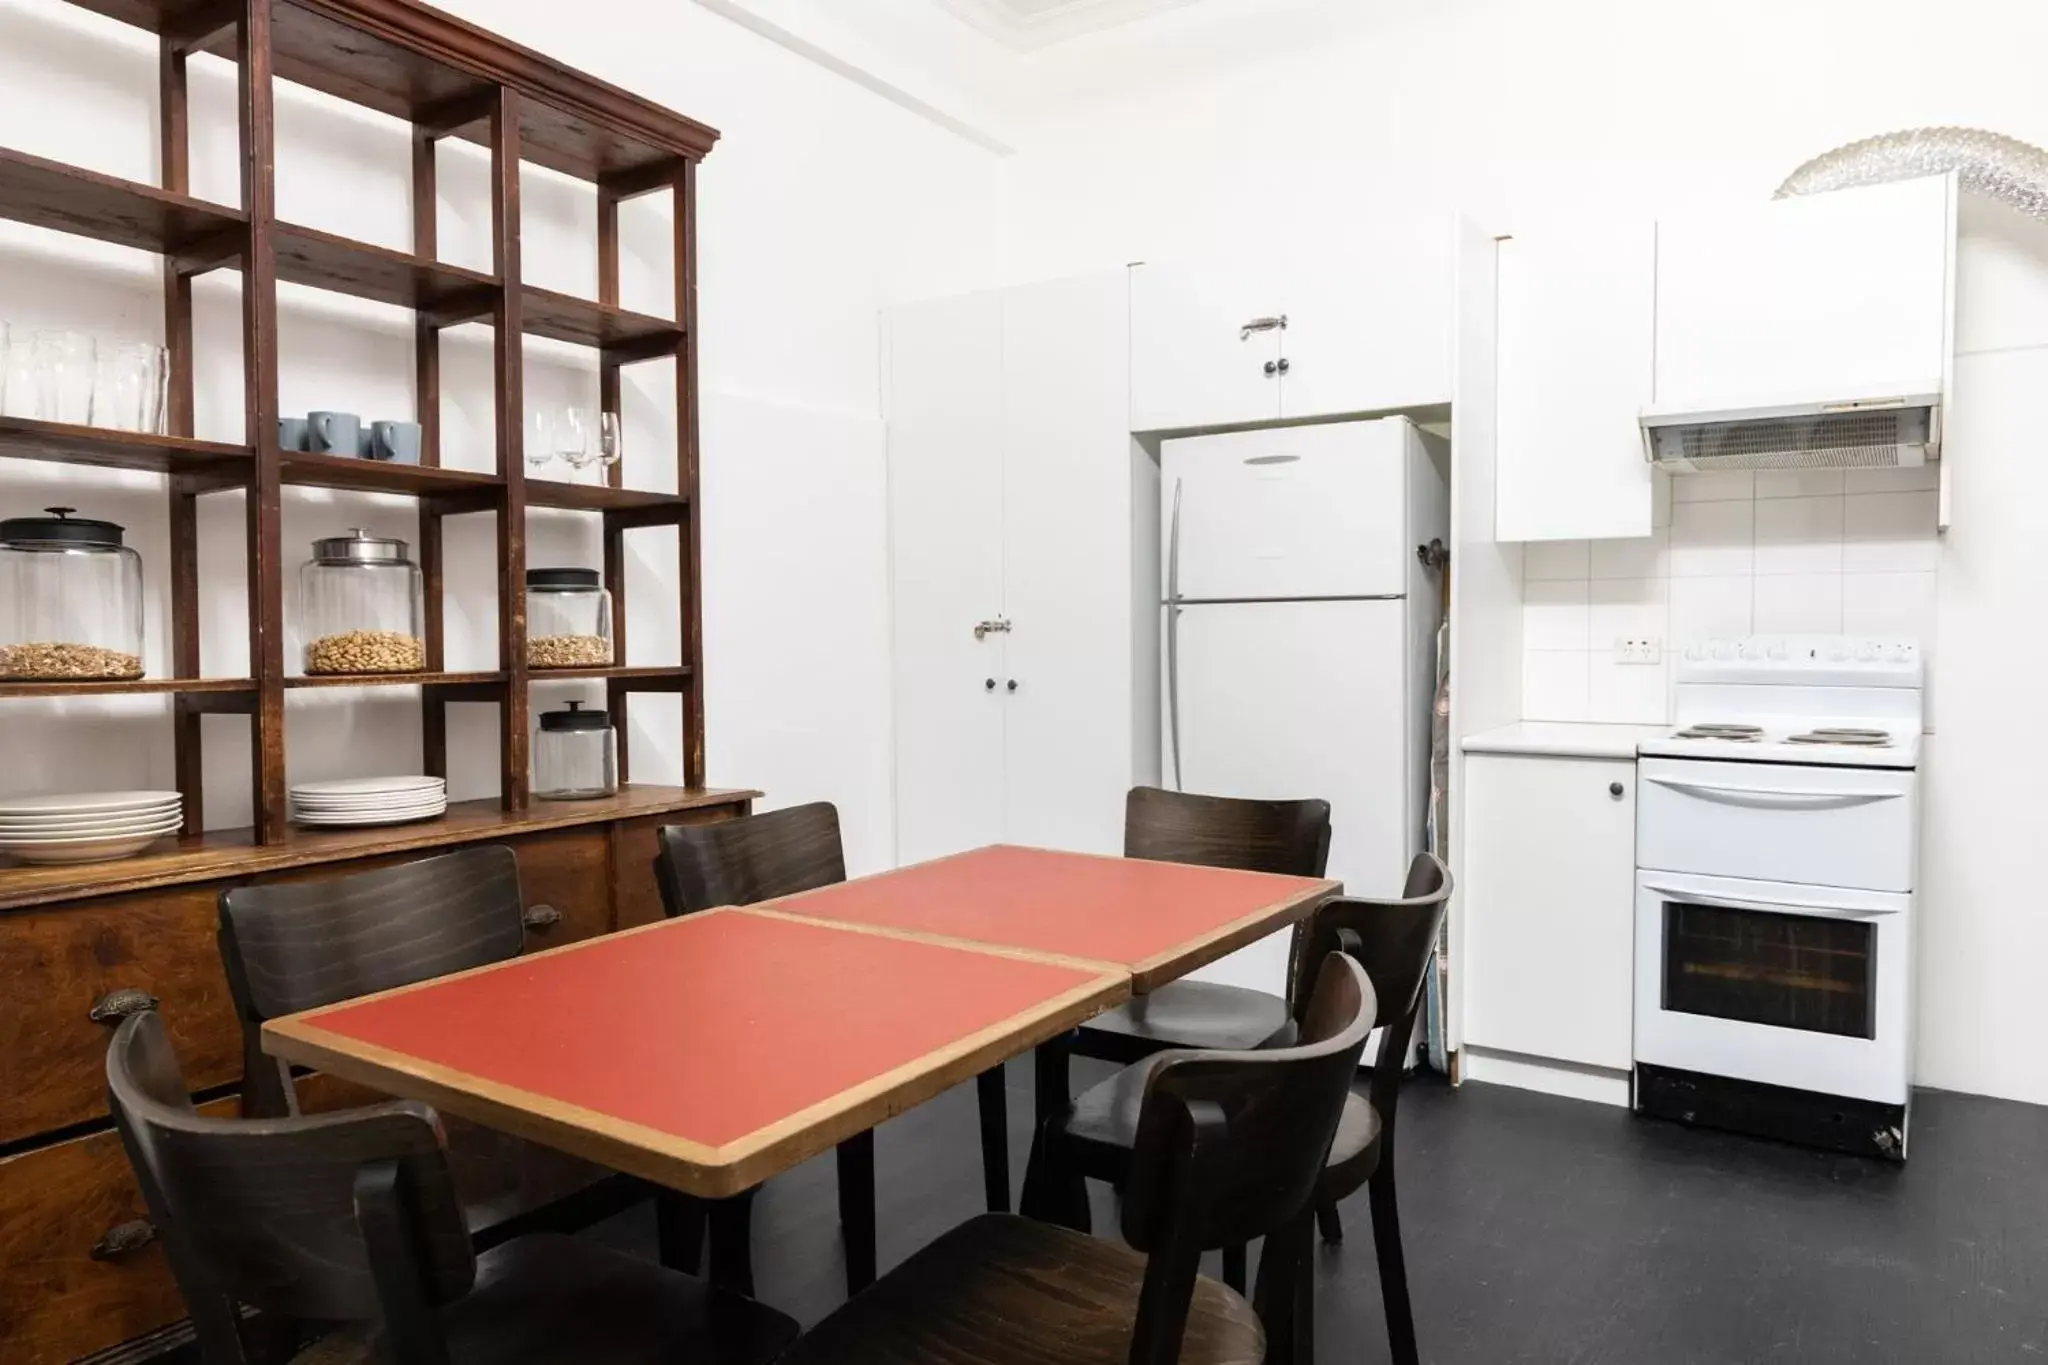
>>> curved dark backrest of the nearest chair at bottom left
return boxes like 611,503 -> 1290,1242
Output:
106,1011 -> 475,1365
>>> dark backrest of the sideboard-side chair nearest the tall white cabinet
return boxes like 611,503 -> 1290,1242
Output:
653,800 -> 846,919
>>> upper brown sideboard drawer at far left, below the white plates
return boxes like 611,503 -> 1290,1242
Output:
0,884 -> 242,1142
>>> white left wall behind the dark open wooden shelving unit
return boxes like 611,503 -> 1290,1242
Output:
0,0 -> 1001,870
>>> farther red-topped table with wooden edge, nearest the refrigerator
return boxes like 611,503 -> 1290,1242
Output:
754,845 -> 1343,995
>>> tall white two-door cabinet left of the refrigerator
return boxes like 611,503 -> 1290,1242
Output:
885,270 -> 1159,862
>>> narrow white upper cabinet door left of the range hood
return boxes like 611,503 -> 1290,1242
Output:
1493,223 -> 1657,540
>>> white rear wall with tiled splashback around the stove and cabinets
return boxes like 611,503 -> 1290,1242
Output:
1010,0 -> 2048,1103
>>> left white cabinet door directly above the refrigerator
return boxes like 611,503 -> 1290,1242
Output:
1130,262 -> 1284,432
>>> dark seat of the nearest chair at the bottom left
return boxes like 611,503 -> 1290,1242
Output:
293,1236 -> 799,1365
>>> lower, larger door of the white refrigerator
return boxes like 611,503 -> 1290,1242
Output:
1163,602 -> 1423,993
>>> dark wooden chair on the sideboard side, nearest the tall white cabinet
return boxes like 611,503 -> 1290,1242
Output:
653,800 -> 917,1293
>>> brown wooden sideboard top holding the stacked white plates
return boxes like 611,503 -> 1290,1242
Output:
0,784 -> 760,911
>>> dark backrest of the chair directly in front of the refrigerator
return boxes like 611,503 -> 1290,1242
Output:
1124,786 -> 1329,876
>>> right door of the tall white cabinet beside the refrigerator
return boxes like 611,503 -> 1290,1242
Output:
1001,272 -> 1153,853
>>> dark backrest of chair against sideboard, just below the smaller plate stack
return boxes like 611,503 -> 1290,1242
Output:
219,845 -> 526,1117
